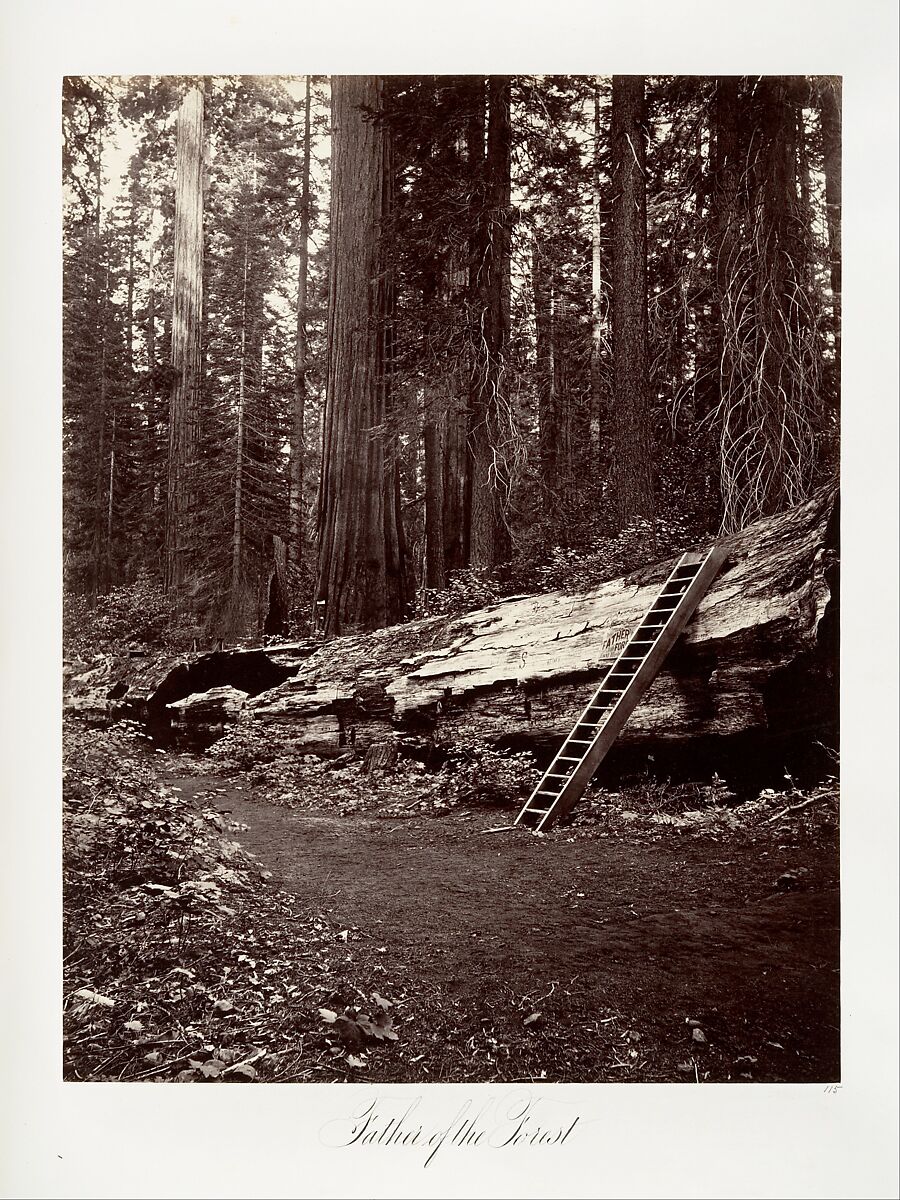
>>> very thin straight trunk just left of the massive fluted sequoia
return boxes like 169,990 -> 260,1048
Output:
288,76 -> 312,571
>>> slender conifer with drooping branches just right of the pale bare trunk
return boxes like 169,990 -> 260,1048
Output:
196,77 -> 296,638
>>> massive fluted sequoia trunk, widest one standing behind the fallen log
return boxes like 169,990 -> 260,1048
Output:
316,76 -> 404,635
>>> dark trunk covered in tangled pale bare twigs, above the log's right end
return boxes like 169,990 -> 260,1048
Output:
714,76 -> 822,530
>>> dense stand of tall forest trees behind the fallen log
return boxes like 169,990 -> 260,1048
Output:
64,76 -> 841,648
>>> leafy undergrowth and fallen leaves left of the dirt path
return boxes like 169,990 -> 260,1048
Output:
64,722 -> 415,1082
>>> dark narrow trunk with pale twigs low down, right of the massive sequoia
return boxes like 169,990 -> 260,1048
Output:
470,76 -> 511,569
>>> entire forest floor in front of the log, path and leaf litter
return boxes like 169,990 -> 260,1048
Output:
65,722 -> 840,1082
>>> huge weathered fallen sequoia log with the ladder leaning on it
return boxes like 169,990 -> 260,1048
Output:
214,490 -> 838,757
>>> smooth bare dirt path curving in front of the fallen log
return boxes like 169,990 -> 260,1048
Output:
173,776 -> 839,1081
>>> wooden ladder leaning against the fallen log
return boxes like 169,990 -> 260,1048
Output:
515,546 -> 725,833
